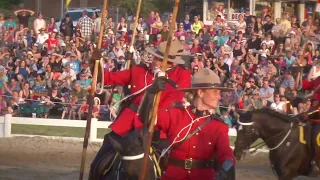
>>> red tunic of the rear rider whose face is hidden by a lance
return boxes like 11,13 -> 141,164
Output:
104,65 -> 191,138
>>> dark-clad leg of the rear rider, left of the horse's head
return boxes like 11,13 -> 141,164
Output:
89,132 -> 121,180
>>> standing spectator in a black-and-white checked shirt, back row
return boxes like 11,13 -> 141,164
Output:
78,10 -> 94,40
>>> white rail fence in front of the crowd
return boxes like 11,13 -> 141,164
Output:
0,114 -> 237,142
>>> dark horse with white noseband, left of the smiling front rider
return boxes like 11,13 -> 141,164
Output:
96,130 -> 164,180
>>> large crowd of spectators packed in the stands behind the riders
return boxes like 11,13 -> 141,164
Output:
0,10 -> 320,126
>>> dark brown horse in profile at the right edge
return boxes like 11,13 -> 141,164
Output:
234,108 -> 320,180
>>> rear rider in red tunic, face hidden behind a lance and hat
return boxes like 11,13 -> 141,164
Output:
89,40 -> 191,179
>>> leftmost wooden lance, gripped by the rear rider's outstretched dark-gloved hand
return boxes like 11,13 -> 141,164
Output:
79,0 -> 108,180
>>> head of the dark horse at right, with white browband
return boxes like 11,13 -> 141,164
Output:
233,112 -> 259,160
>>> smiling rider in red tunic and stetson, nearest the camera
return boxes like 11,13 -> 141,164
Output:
139,68 -> 235,180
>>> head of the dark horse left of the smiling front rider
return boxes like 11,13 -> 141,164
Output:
110,131 -> 155,180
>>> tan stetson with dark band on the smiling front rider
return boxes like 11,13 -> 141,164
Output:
179,68 -> 234,92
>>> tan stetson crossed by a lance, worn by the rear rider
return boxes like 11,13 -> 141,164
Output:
146,39 -> 185,64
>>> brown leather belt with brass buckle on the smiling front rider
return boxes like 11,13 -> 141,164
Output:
168,158 -> 215,170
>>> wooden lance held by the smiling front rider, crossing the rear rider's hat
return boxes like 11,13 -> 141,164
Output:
140,0 -> 180,180
